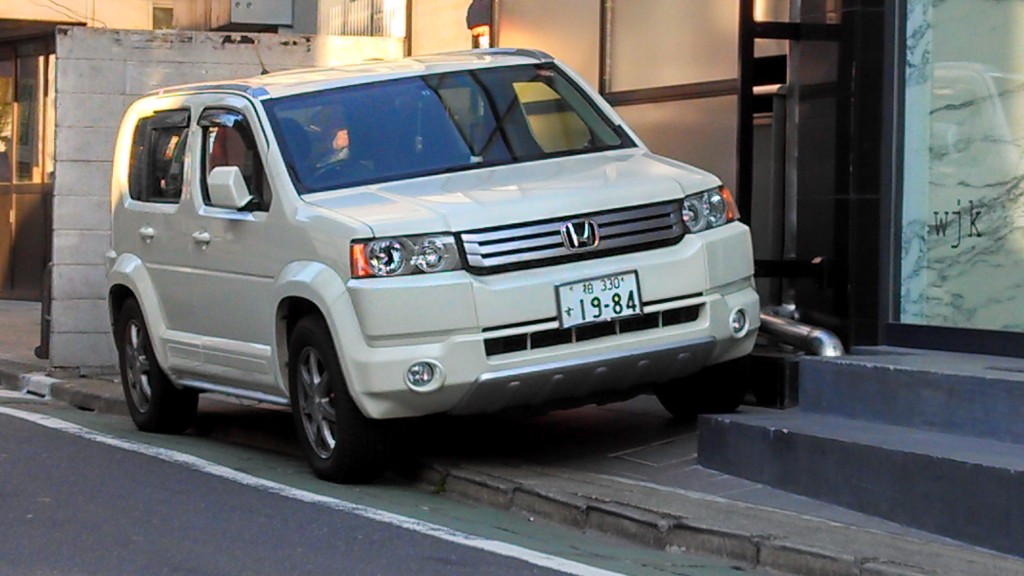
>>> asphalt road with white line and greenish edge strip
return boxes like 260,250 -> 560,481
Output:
0,398 -> 761,576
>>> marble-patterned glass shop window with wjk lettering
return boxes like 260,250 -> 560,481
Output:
900,0 -> 1024,331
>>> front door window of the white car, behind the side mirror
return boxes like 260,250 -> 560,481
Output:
199,109 -> 270,211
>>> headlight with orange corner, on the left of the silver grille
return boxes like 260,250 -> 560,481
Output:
349,235 -> 461,278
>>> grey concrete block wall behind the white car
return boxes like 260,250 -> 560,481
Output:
50,28 -> 403,369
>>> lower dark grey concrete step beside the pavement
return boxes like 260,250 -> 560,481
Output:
697,408 -> 1024,557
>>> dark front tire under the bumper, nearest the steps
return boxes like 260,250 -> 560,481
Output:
654,357 -> 751,421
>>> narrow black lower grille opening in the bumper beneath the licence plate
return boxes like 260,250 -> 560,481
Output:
483,304 -> 702,356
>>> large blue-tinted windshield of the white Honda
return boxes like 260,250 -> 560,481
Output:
265,65 -> 635,194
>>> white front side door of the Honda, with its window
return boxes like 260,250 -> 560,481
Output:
188,97 -> 280,394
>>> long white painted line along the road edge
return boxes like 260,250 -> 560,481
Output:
0,406 -> 618,576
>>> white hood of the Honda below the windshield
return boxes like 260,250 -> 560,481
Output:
304,150 -> 721,237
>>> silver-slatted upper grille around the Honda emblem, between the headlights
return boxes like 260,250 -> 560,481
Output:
458,202 -> 684,274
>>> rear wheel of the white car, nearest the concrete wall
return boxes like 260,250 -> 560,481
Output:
115,298 -> 199,434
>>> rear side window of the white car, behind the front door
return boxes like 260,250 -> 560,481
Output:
128,110 -> 188,204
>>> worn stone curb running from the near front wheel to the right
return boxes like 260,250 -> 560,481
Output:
399,462 -> 1024,576
